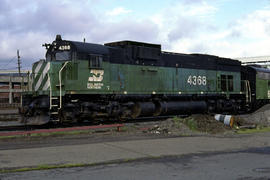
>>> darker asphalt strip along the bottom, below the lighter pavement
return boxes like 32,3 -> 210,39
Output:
0,147 -> 270,180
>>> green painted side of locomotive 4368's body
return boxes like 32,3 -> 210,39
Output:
29,60 -> 243,96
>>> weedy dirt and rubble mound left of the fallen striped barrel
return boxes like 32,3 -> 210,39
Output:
122,114 -> 233,136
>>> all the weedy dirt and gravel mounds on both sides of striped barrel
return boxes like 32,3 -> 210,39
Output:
123,104 -> 270,136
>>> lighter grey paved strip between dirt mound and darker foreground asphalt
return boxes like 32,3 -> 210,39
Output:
0,133 -> 270,169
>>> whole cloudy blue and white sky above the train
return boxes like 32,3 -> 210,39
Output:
0,0 -> 270,70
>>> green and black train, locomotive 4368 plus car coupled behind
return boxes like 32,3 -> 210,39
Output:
20,35 -> 270,124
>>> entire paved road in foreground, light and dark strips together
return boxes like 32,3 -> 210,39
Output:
0,133 -> 270,180
